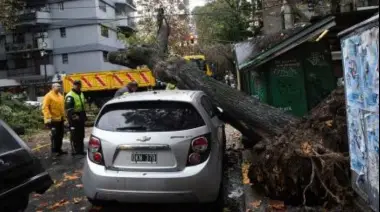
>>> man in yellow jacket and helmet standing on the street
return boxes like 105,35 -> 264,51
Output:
42,83 -> 67,155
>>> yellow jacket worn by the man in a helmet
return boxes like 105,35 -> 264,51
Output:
42,91 -> 65,124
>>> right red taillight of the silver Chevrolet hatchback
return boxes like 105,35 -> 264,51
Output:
187,134 -> 211,166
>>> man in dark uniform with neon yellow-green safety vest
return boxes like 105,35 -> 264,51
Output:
65,80 -> 87,155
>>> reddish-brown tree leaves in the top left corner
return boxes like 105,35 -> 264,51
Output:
0,0 -> 25,30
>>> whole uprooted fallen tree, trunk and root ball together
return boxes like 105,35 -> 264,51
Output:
108,7 -> 349,205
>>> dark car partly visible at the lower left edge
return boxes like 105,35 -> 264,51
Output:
0,120 -> 53,211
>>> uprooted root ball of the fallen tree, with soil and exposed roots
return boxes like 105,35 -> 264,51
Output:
249,88 -> 351,207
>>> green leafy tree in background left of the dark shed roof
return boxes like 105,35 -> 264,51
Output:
192,0 -> 253,45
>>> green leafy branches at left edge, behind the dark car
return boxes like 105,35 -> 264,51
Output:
0,93 -> 43,134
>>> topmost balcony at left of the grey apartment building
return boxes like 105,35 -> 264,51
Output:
17,7 -> 52,26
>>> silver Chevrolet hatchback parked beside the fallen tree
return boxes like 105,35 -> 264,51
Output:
82,90 -> 225,209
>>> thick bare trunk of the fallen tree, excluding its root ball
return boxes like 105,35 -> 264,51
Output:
108,9 -> 297,141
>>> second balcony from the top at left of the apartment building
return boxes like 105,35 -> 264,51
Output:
5,38 -> 53,54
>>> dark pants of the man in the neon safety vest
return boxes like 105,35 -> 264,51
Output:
70,121 -> 85,154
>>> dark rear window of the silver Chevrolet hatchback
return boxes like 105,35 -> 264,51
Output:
96,101 -> 205,132
